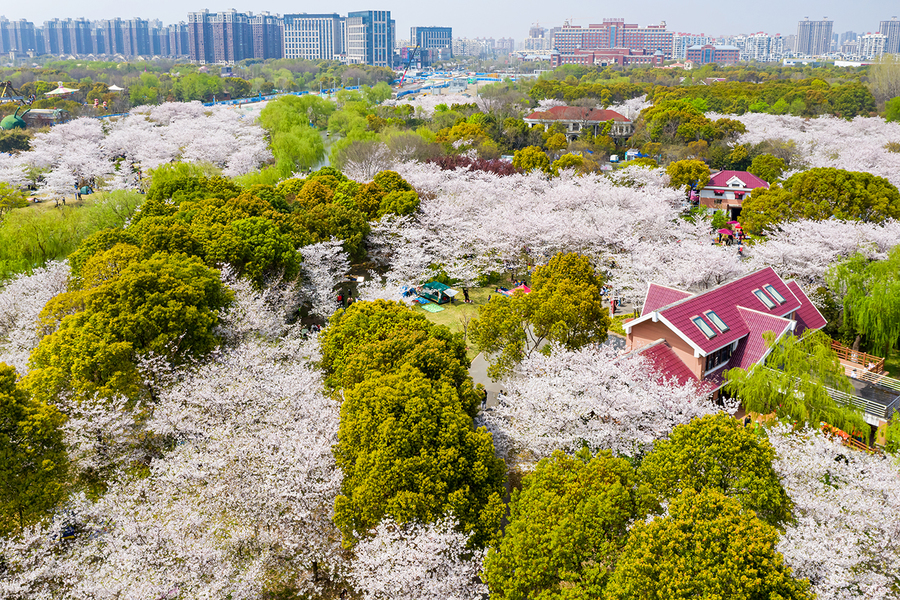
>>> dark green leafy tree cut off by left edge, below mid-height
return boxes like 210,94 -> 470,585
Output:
0,363 -> 69,534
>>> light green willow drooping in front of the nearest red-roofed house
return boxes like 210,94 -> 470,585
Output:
724,331 -> 868,433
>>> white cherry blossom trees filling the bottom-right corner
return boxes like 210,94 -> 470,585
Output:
768,426 -> 900,600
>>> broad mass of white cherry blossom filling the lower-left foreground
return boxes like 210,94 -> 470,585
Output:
0,340 -> 346,599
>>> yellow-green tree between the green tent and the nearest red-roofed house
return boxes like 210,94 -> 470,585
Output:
469,253 -> 611,379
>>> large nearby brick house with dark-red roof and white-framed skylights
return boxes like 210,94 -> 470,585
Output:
625,268 -> 826,392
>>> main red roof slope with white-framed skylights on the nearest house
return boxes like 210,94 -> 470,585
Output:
658,268 -> 801,354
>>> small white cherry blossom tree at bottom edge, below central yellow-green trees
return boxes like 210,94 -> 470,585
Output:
350,519 -> 487,600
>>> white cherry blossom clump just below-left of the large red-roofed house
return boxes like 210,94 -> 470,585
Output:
474,346 -> 735,469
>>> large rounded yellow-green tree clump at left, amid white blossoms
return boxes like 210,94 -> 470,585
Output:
24,247 -> 231,398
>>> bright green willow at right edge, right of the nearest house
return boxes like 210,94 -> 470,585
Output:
828,246 -> 900,356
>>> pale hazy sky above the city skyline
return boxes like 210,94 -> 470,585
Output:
0,0 -> 900,41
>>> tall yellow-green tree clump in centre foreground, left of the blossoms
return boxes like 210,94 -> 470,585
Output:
321,301 -> 505,546
